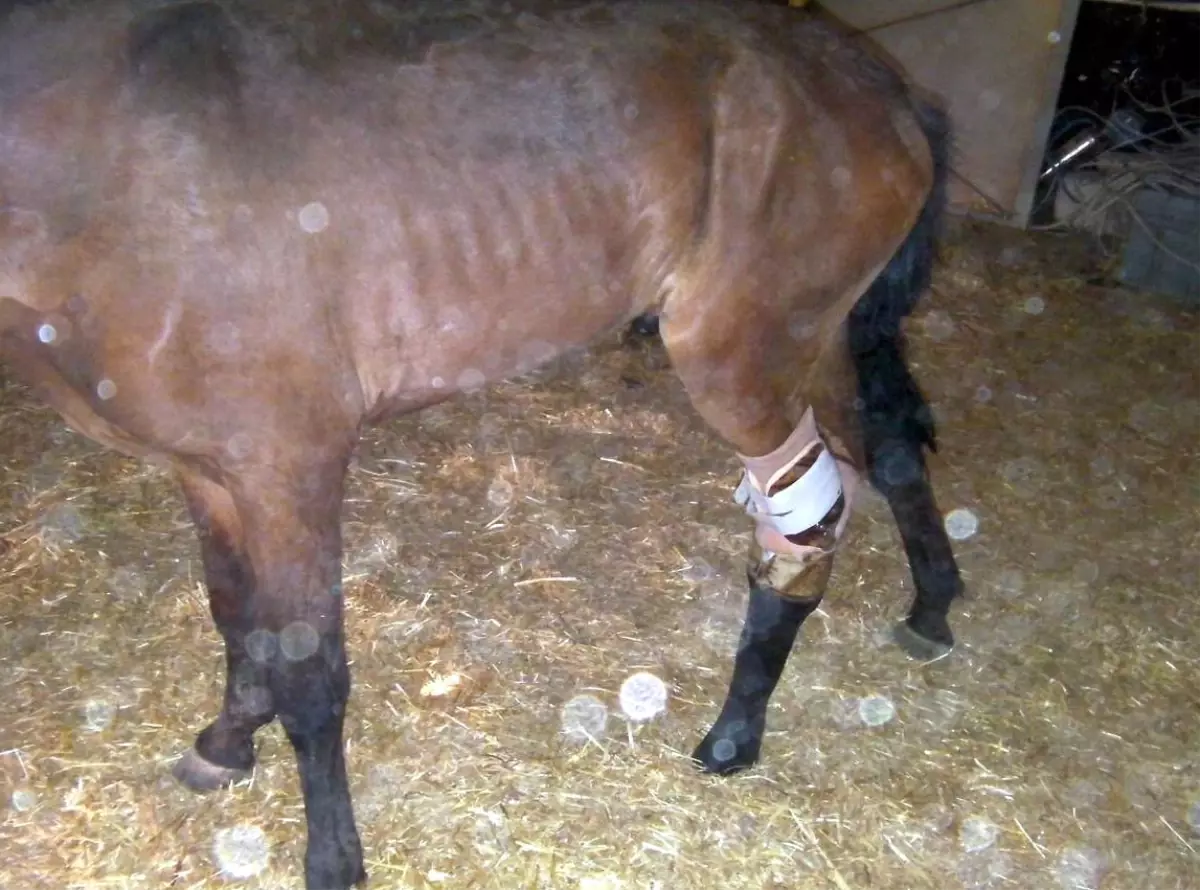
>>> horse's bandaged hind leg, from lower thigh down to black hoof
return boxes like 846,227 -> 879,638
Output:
661,281 -> 854,774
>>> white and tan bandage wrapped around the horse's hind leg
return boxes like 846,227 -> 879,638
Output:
733,408 -> 858,599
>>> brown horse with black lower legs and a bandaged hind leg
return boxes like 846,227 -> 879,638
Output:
0,0 -> 960,890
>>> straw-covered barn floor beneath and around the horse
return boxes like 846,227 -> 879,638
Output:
0,223 -> 1200,890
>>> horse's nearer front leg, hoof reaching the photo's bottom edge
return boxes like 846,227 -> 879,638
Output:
229,453 -> 366,890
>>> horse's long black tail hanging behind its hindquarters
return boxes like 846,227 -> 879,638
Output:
847,98 -> 952,467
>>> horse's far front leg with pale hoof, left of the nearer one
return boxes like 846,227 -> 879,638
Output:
174,469 -> 275,792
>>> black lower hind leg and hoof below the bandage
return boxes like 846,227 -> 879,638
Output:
692,577 -> 821,775
